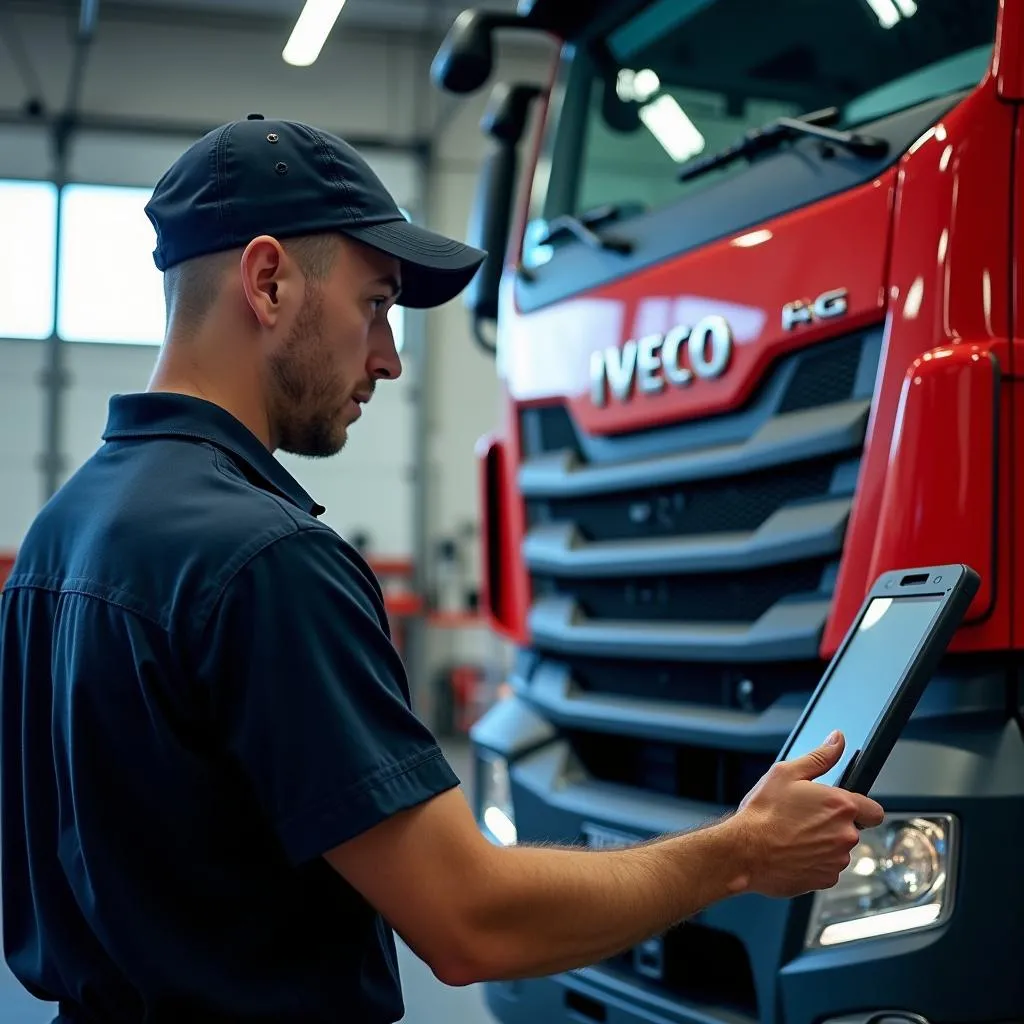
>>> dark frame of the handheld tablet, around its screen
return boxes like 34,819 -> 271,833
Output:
778,564 -> 981,795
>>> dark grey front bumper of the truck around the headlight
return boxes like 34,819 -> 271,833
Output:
474,699 -> 1024,1024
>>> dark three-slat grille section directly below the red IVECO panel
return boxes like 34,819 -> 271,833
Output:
520,328 -> 882,667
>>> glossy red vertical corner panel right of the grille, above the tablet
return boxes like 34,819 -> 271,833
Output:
823,78 -> 1019,655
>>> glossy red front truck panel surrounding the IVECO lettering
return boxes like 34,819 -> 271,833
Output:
501,170 -> 896,434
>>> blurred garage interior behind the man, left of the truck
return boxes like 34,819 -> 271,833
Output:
0,0 -> 551,1024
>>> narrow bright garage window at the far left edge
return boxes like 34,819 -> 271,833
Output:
0,180 -> 57,340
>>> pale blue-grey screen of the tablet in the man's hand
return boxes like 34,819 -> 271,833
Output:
786,595 -> 942,785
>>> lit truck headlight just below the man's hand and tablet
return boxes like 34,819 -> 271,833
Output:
806,814 -> 956,947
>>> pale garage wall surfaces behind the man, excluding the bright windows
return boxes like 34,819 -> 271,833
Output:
0,5 -> 551,659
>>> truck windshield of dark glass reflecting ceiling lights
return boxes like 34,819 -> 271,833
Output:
527,0 -> 998,233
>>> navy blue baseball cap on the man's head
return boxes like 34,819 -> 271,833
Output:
145,114 -> 486,309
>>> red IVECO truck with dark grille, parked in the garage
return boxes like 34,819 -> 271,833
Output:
434,6 -> 1024,1024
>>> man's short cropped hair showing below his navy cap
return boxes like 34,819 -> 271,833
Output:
164,233 -> 340,331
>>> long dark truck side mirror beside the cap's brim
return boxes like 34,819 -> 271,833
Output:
463,83 -> 542,353
